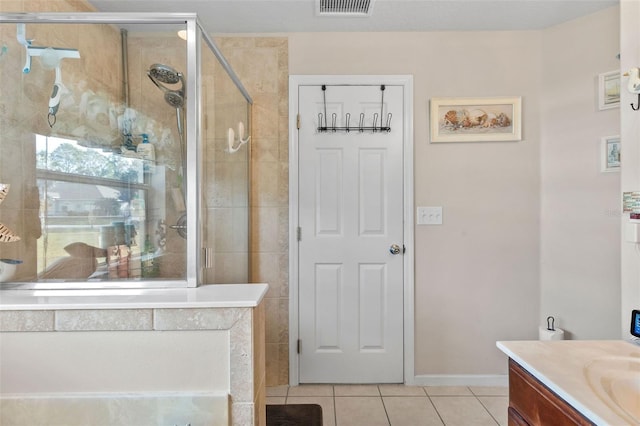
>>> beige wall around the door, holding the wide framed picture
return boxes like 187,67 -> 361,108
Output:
290,32 -> 541,376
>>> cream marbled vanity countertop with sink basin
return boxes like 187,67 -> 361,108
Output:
497,340 -> 640,426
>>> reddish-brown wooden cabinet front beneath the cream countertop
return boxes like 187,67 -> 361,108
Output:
508,359 -> 594,426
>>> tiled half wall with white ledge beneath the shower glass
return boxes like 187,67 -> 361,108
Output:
0,284 -> 268,426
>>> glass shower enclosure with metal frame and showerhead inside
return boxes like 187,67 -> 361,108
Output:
0,13 -> 251,289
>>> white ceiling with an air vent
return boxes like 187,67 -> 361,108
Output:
90,0 -> 619,34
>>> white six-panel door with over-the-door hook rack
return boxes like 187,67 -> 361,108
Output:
298,85 -> 404,383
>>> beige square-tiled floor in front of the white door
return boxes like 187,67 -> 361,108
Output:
267,385 -> 509,426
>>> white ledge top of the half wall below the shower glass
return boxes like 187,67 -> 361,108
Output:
0,284 -> 269,311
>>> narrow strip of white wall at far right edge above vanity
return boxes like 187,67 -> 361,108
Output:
619,0 -> 640,338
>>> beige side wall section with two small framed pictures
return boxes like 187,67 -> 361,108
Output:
540,7 -> 620,339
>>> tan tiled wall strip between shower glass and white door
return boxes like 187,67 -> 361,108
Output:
215,37 -> 289,386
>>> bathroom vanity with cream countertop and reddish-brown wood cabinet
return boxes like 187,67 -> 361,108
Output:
497,340 -> 640,426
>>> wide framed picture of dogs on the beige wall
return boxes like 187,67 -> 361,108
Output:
430,96 -> 522,143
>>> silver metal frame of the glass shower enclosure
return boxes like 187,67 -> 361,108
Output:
0,12 -> 253,289
